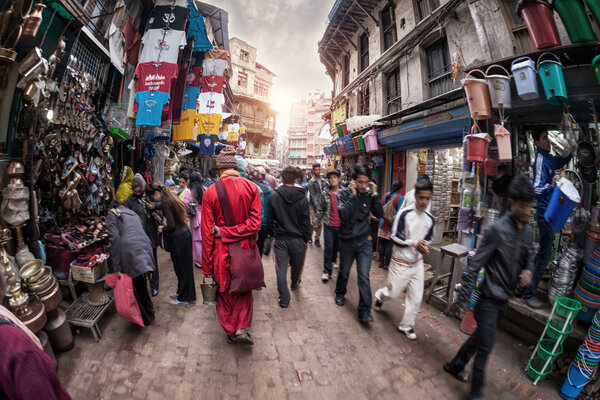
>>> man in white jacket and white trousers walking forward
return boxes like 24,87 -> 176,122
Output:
374,178 -> 435,340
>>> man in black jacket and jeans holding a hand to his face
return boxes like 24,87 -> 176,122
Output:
335,164 -> 383,323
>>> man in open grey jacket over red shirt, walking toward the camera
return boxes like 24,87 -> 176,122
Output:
313,169 -> 342,282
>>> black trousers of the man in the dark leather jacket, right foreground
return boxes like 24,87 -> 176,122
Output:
450,297 -> 508,399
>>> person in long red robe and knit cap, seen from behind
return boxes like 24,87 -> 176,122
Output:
202,147 -> 262,344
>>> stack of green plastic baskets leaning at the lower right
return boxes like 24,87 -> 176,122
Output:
527,297 -> 581,385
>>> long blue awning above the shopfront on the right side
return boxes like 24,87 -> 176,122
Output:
377,107 -> 470,151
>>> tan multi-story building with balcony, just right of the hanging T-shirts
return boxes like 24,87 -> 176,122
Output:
229,38 -> 278,159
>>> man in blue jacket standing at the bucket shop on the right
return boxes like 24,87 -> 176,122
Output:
522,130 -> 571,309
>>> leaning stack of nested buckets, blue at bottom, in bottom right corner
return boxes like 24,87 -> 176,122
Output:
560,313 -> 600,400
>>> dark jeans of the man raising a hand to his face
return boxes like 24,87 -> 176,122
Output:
335,240 -> 373,316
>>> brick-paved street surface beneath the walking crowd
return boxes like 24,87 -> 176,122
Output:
58,242 -> 562,400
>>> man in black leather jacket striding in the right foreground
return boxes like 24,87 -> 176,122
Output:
444,175 -> 536,400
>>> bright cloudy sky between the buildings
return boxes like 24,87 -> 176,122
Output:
214,0 -> 335,142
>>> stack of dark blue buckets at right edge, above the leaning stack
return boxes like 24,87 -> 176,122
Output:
575,249 -> 600,322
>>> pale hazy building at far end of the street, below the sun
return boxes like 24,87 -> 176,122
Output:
288,90 -> 331,168
